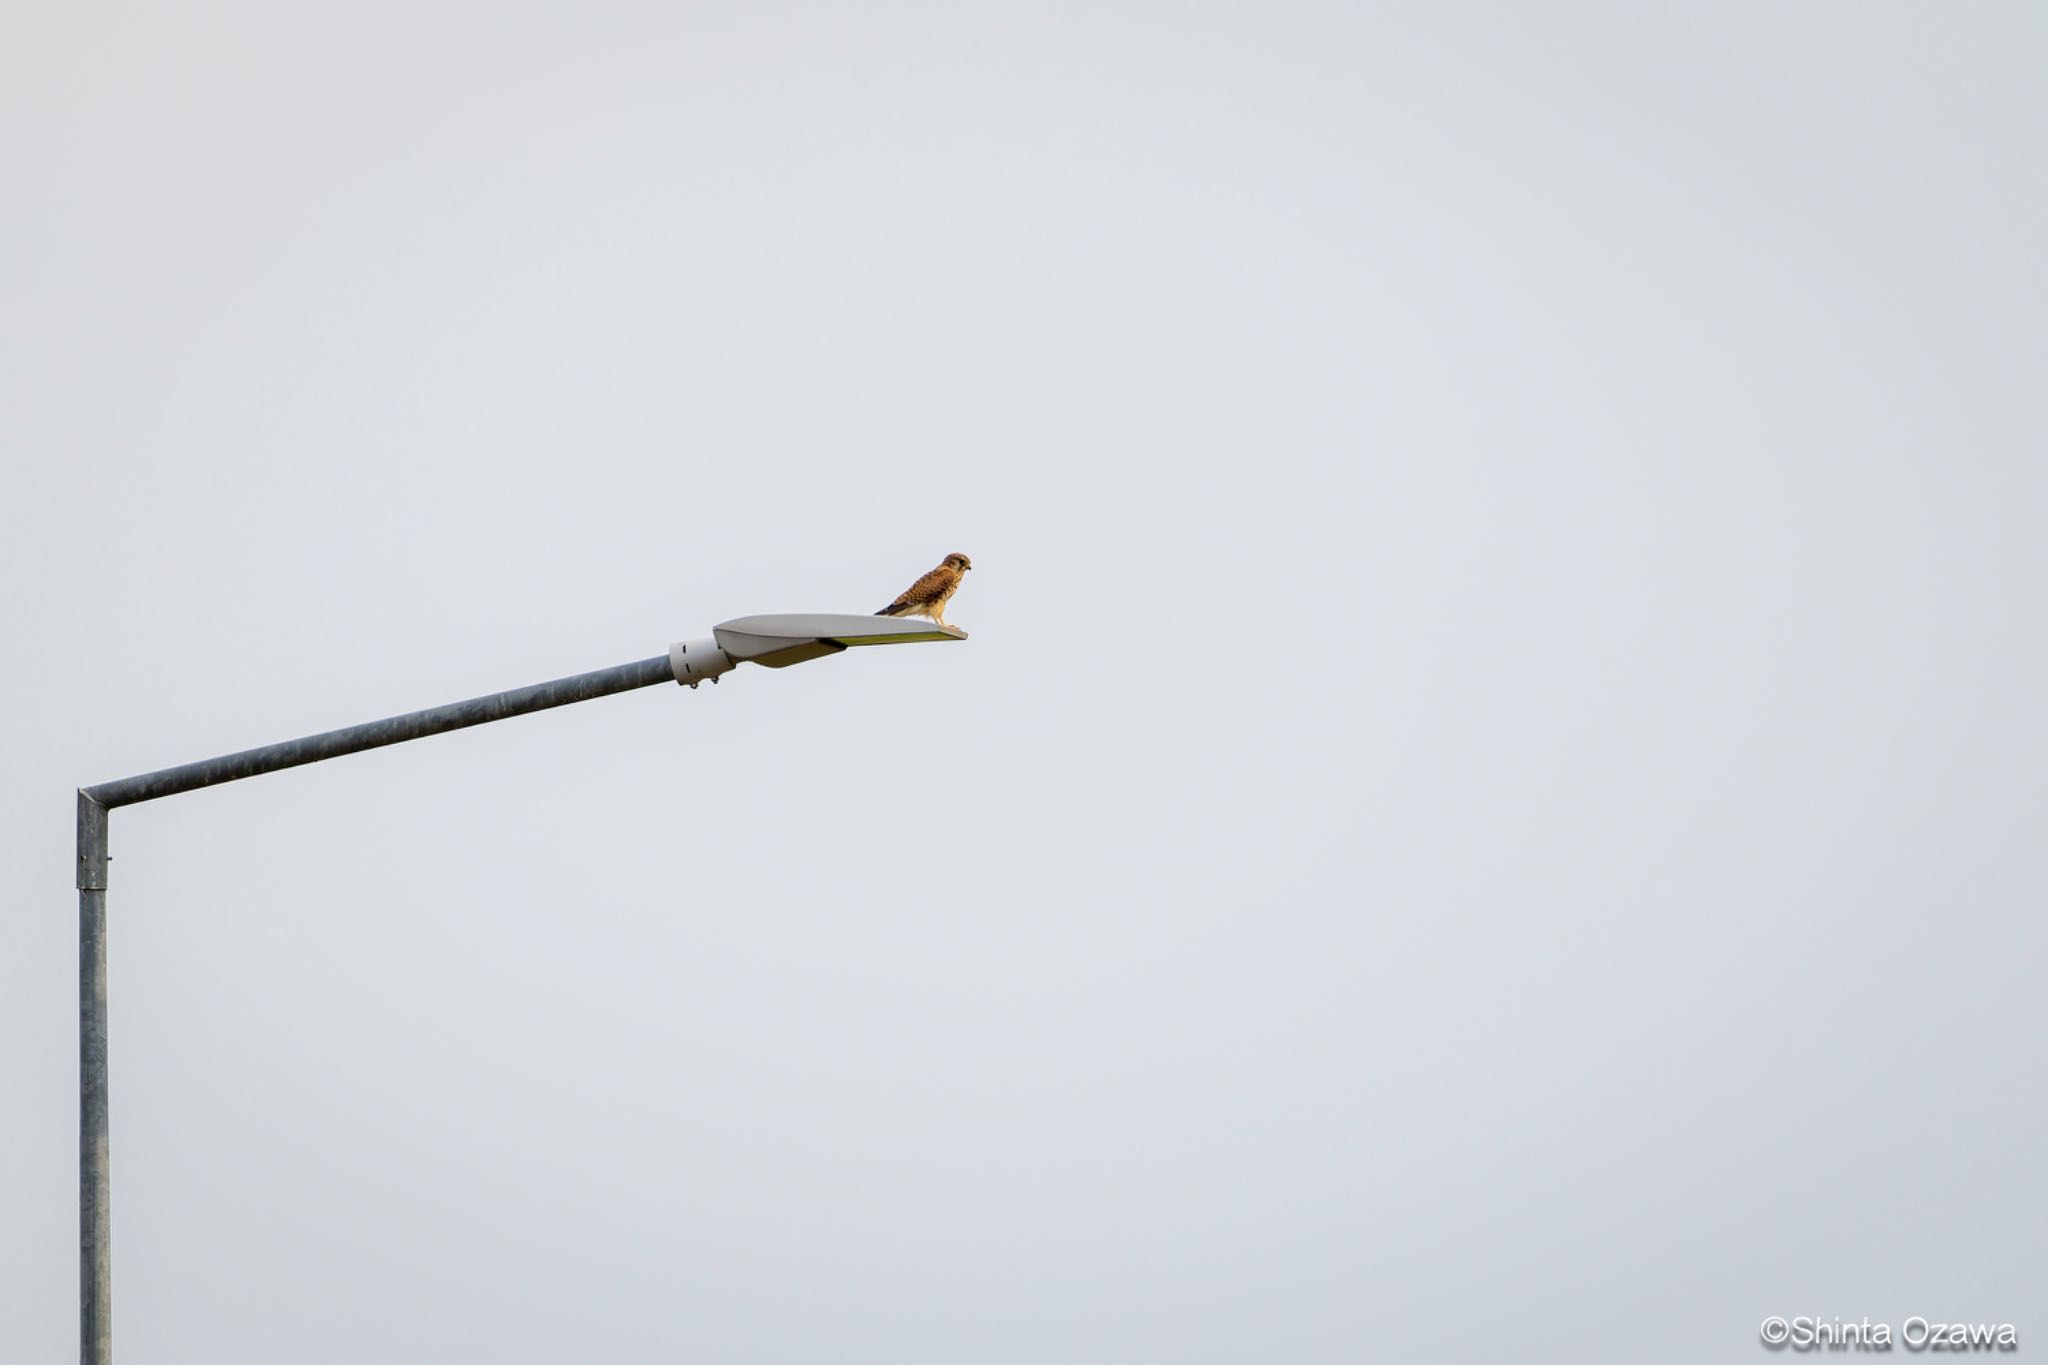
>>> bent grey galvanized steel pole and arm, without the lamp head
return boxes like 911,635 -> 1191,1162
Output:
78,655 -> 679,1365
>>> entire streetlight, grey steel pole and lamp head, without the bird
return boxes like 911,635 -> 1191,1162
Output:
78,614 -> 967,1365
